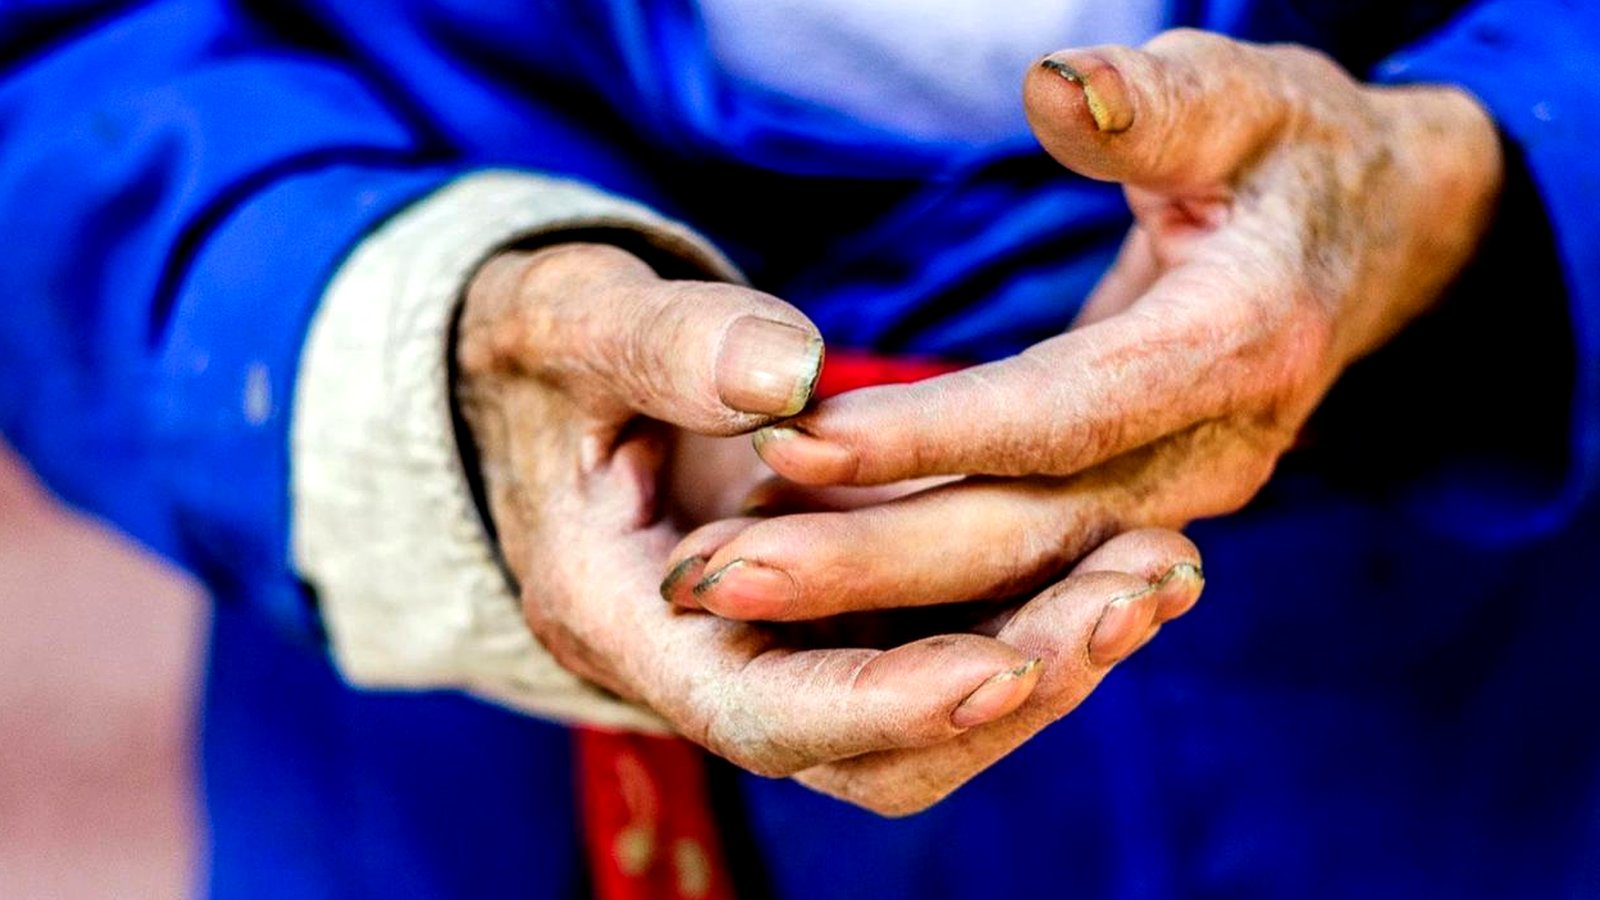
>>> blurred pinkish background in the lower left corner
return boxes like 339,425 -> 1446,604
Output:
0,444 -> 206,900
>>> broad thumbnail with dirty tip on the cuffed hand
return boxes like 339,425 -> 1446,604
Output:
717,315 -> 822,416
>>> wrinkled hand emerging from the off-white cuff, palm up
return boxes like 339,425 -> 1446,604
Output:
456,245 -> 1198,812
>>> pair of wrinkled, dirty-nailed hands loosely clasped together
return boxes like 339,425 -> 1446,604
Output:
456,32 -> 1502,815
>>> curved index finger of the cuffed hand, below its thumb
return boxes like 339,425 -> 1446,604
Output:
563,525 -> 1038,775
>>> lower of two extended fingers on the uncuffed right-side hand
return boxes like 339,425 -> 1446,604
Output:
694,426 -> 1235,621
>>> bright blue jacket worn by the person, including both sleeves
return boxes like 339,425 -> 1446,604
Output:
0,0 -> 1600,898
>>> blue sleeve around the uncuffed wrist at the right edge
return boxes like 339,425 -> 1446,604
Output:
1350,0 -> 1600,543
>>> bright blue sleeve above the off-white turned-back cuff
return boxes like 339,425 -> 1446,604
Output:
0,0 -> 454,639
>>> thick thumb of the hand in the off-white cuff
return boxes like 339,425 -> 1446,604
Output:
474,245 -> 822,434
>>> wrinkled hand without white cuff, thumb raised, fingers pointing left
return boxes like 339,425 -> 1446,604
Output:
680,32 -> 1502,620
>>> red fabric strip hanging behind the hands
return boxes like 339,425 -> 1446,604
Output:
574,352 -> 958,900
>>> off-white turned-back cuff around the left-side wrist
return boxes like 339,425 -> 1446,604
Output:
291,171 -> 738,730
